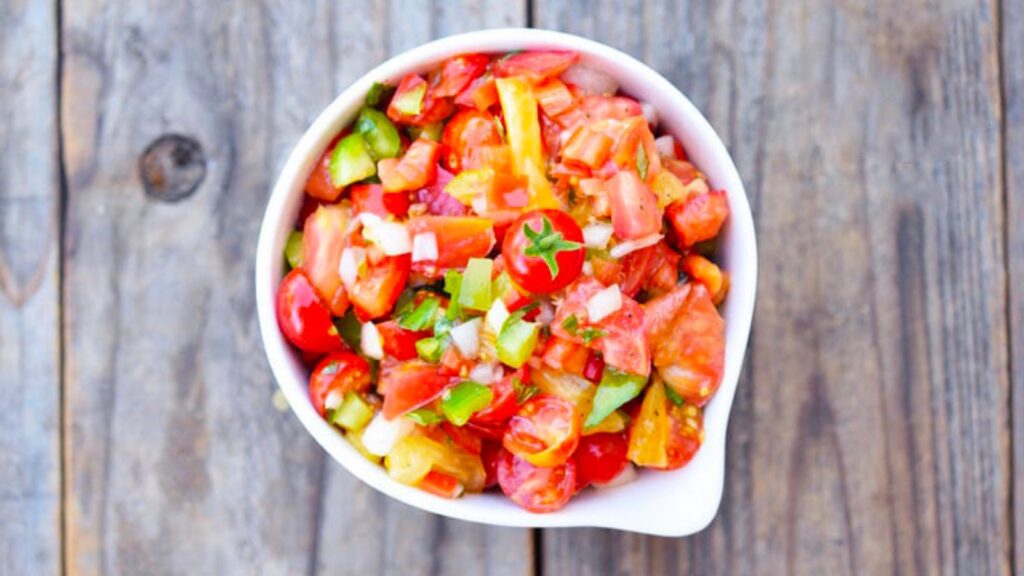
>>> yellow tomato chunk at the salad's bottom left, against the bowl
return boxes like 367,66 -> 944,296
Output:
384,434 -> 486,492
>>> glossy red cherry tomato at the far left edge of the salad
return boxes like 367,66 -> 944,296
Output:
276,269 -> 345,353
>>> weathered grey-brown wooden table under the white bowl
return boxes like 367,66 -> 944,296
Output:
0,0 -> 1024,576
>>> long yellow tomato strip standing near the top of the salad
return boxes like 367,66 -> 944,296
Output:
495,76 -> 560,208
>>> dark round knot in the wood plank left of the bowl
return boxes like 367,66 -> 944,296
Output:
138,134 -> 206,202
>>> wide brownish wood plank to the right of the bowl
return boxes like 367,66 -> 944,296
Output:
535,0 -> 1016,574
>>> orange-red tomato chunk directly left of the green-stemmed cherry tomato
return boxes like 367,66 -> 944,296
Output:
408,216 -> 496,278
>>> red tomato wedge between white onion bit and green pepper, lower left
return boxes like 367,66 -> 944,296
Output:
377,359 -> 458,420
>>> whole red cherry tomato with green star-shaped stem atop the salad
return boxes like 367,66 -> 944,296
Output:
502,210 -> 585,294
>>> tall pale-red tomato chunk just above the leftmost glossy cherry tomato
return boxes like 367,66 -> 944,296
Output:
302,205 -> 349,316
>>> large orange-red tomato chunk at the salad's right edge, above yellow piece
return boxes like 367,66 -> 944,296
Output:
645,284 -> 725,406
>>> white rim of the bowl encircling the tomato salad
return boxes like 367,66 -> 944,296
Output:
254,28 -> 758,536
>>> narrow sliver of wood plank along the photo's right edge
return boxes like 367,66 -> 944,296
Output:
1000,0 -> 1024,574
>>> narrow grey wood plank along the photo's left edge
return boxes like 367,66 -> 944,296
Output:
0,2 -> 61,574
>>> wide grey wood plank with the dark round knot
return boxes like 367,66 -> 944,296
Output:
63,0 -> 531,574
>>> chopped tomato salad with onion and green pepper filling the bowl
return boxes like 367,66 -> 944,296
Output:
276,51 -> 729,512
